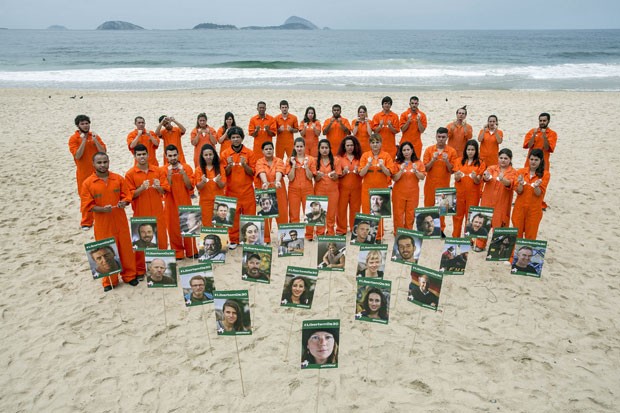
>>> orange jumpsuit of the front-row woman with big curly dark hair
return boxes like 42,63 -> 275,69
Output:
336,154 -> 362,235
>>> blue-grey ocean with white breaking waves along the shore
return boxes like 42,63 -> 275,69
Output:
0,30 -> 620,91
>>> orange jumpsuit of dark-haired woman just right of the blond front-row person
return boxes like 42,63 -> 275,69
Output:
392,159 -> 426,235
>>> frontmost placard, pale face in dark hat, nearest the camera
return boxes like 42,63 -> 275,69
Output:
301,320 -> 340,369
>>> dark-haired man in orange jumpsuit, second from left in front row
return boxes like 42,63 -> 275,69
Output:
125,145 -> 170,277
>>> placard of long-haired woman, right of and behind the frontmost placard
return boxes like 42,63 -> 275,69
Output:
355,278 -> 392,324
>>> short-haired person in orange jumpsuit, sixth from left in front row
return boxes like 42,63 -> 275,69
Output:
254,142 -> 292,243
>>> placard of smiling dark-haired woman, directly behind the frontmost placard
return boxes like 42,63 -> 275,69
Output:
280,266 -> 319,308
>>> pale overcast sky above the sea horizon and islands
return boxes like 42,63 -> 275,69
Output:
0,0 -> 620,29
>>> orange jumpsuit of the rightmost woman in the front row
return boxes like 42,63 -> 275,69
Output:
512,168 -> 550,239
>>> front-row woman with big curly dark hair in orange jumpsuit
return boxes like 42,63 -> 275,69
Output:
336,136 -> 362,235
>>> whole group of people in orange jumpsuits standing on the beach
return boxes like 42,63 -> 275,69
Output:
69,96 -> 557,291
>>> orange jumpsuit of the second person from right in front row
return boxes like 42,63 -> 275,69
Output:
480,165 -> 517,228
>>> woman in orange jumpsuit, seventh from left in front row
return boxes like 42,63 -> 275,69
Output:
284,138 -> 316,239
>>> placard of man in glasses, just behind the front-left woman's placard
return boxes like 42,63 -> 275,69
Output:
179,262 -> 215,307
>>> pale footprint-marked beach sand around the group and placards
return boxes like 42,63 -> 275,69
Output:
0,89 -> 620,412
